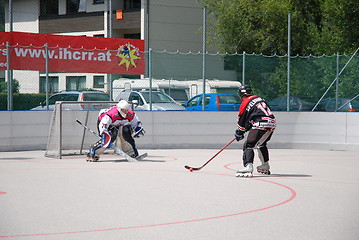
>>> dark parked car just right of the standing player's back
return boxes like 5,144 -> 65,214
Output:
269,96 -> 325,111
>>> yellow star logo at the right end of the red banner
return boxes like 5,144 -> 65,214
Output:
116,43 -> 141,71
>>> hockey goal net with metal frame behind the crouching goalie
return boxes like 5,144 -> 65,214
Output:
45,102 -> 117,158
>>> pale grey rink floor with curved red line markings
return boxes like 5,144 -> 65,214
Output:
0,149 -> 359,240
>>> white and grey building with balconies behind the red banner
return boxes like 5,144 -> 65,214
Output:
4,0 -> 236,93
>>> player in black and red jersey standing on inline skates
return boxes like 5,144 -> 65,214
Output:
234,85 -> 276,177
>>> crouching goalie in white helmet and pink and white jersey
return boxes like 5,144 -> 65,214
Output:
87,100 -> 145,162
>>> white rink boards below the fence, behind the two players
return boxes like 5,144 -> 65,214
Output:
0,111 -> 359,151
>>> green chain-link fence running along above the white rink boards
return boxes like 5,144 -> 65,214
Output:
0,51 -> 359,111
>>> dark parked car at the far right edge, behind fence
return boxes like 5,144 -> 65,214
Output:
320,98 -> 359,112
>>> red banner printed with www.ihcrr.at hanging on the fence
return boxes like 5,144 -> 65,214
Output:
0,32 -> 145,75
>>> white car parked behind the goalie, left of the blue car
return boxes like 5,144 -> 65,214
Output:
116,90 -> 186,111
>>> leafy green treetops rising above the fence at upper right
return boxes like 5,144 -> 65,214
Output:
203,0 -> 359,56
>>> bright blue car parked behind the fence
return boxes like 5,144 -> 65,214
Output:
183,93 -> 240,111
